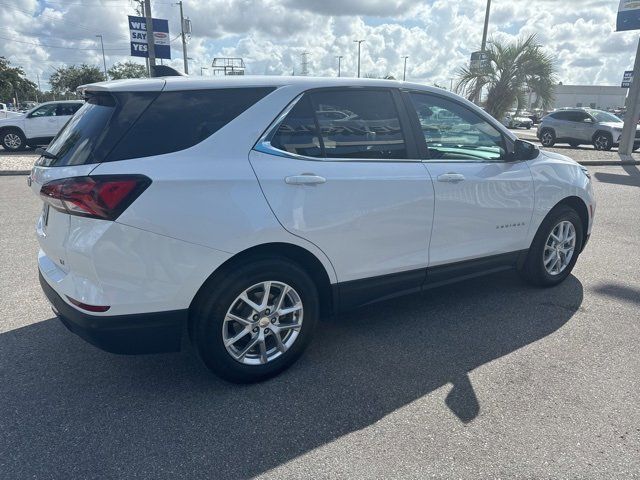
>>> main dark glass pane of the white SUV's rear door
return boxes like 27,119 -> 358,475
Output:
311,90 -> 407,159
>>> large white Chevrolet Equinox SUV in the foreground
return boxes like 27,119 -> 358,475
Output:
29,76 -> 595,382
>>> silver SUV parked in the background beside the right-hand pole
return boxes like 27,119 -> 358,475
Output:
537,108 -> 640,150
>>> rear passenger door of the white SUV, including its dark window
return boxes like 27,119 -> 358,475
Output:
250,88 -> 433,291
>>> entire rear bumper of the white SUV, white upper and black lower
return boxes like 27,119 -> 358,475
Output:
38,217 -> 231,354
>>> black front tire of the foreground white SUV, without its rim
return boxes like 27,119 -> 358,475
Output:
519,205 -> 584,287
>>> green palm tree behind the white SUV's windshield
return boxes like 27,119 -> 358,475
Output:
455,35 -> 556,119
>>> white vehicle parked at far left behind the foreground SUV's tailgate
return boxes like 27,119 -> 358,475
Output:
0,100 -> 83,152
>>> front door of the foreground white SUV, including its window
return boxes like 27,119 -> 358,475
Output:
405,92 -> 534,266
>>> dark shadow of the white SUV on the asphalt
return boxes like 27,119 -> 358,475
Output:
0,272 -> 583,479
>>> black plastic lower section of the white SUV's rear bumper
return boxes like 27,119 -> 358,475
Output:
39,273 -> 188,355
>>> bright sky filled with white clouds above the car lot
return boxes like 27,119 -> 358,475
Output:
0,0 -> 637,91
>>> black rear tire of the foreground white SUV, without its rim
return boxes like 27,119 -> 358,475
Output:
191,257 -> 320,383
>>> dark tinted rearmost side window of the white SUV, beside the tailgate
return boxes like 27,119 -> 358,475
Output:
107,88 -> 274,161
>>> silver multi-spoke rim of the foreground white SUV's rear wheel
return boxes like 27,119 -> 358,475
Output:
222,281 -> 304,365
